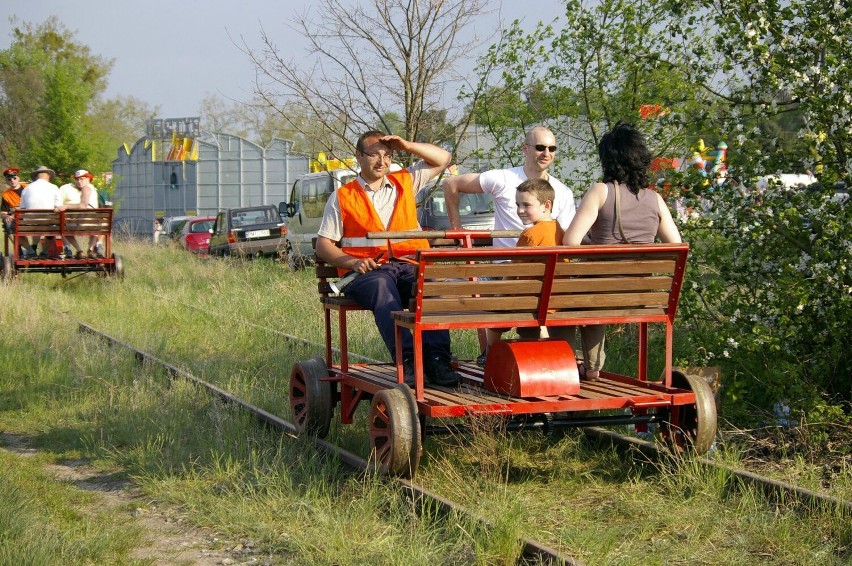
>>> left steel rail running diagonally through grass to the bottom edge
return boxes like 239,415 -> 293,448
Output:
75,324 -> 583,566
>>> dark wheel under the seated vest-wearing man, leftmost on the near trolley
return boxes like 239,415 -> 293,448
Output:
290,356 -> 334,438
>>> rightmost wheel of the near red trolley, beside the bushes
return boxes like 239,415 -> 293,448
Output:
662,370 -> 717,454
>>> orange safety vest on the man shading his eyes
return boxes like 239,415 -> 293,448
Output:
337,169 -> 429,275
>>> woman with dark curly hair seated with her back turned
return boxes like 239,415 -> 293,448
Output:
562,122 -> 681,381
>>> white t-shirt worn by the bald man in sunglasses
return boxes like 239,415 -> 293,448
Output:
479,166 -> 576,248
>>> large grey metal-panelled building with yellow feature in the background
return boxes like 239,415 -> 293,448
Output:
112,117 -> 309,234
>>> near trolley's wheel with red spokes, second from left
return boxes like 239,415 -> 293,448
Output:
370,383 -> 423,478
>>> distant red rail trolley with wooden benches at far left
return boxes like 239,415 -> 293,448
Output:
0,208 -> 124,281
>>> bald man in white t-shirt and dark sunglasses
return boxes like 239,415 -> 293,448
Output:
444,126 -> 576,365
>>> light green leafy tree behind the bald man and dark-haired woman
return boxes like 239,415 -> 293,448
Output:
467,0 -> 708,189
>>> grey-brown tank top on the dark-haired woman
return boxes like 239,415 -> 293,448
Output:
590,183 -> 660,244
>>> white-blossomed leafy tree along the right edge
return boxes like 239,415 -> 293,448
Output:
673,0 -> 852,418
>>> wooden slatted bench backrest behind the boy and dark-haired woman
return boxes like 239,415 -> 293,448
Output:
413,244 -> 689,325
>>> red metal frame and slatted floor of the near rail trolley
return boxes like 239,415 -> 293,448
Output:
325,240 -> 695,430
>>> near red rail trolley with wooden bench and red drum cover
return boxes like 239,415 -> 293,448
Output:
290,231 -> 717,477
